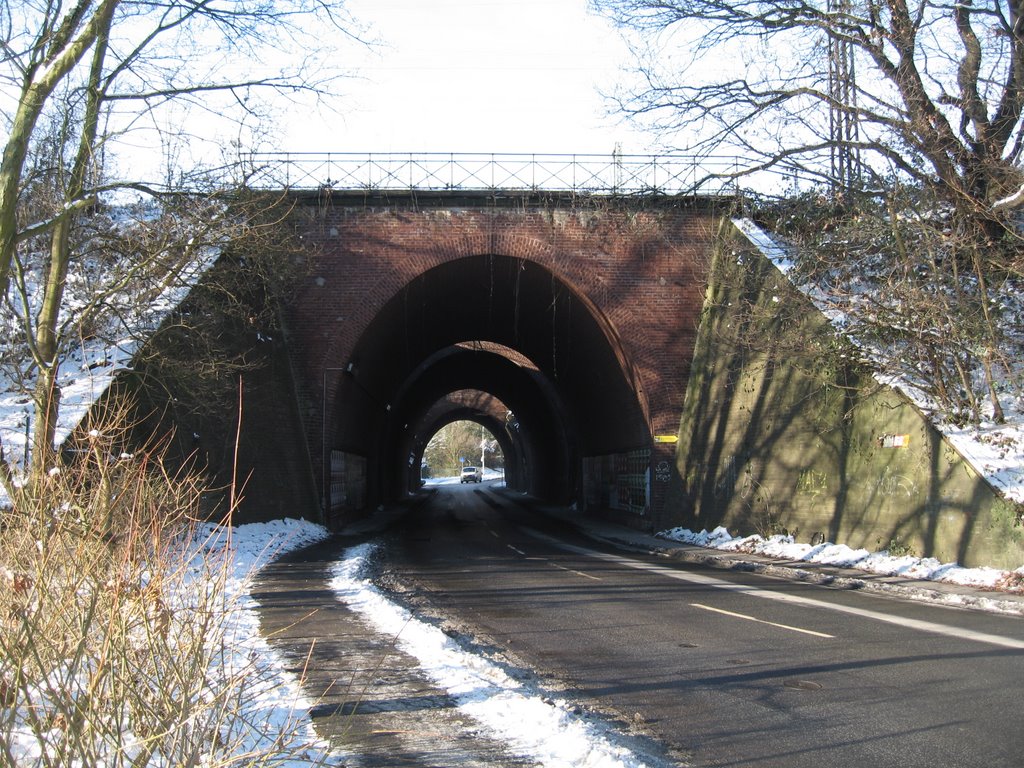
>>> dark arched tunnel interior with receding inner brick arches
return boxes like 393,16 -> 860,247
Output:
325,254 -> 650,514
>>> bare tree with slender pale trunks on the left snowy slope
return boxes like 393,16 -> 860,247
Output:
0,0 -> 364,499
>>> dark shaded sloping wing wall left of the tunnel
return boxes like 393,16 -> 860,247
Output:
112,254 -> 322,522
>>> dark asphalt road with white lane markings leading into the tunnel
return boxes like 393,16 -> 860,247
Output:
384,484 -> 1024,768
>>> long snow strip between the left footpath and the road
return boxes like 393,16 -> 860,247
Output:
332,545 -> 643,768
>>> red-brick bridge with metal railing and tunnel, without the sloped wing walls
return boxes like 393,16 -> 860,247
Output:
254,156 -> 729,526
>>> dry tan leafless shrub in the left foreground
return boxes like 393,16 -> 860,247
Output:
0,405 -> 323,766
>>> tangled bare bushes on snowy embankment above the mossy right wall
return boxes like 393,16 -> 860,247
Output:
765,186 -> 1024,426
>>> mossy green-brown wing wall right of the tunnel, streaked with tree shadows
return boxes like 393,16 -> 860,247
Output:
669,224 -> 1024,568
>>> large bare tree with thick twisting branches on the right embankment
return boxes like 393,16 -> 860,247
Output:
593,0 -> 1024,421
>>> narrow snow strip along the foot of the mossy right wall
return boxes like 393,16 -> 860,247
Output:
657,525 -> 1024,592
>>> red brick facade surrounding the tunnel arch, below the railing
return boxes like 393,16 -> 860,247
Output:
288,196 -> 722,524
